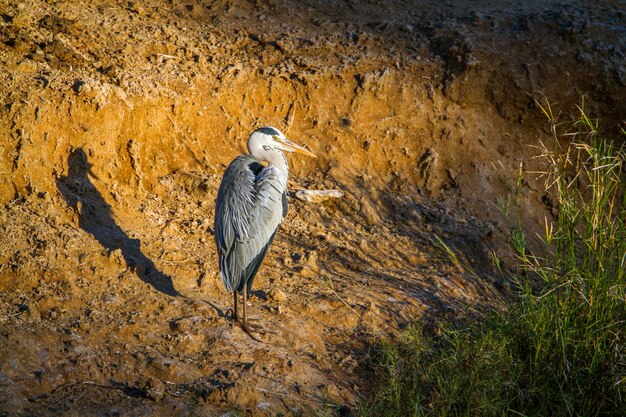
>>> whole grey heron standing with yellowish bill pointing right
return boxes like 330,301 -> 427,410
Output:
214,126 -> 315,340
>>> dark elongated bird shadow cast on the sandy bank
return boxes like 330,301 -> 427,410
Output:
56,148 -> 180,296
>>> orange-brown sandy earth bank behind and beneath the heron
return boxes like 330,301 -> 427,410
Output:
0,0 -> 626,416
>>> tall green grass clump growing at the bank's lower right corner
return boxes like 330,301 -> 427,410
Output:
362,105 -> 626,416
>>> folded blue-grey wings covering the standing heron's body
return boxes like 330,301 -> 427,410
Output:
215,156 -> 285,292
